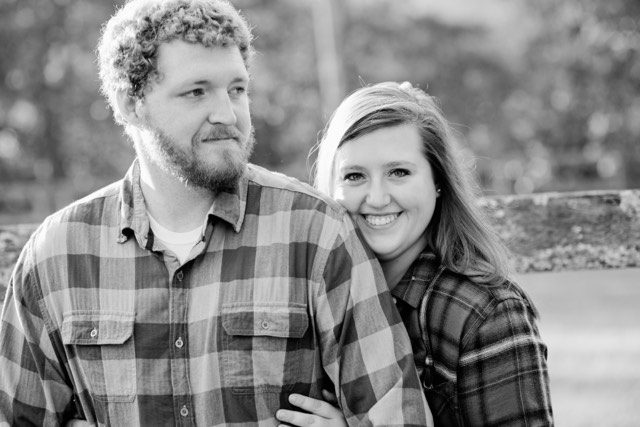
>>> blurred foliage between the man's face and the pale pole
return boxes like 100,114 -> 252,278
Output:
233,0 -> 323,180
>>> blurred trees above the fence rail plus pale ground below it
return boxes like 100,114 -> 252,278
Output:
0,0 -> 640,426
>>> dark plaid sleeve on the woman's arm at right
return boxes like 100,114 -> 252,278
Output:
457,298 -> 553,426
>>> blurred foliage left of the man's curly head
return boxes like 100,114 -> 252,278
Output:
0,0 -> 131,217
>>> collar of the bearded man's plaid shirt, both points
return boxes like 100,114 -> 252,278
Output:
118,159 -> 252,247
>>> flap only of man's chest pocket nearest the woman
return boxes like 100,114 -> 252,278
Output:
222,303 -> 309,338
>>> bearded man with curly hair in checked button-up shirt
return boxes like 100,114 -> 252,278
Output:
0,0 -> 430,425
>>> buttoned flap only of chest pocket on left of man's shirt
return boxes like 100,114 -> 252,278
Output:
60,310 -> 135,345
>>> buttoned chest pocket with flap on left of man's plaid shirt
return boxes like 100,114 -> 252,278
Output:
61,310 -> 136,402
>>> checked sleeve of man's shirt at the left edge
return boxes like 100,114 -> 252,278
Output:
0,244 -> 74,426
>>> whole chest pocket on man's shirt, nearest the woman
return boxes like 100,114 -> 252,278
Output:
221,303 -> 312,394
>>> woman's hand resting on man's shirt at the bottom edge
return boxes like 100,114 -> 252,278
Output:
276,390 -> 347,427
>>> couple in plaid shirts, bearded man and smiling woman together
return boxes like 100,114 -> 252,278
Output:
0,0 -> 552,426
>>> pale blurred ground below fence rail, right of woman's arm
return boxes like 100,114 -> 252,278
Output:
518,269 -> 640,427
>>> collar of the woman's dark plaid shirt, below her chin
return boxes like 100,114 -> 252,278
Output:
391,252 -> 441,308
